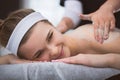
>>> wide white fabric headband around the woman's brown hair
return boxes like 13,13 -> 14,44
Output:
6,12 -> 46,55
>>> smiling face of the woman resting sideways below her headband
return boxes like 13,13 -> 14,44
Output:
19,22 -> 70,61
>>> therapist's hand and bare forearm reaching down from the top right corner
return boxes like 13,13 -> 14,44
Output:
80,0 -> 120,43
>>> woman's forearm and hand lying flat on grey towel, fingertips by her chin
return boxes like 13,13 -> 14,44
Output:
53,53 -> 120,69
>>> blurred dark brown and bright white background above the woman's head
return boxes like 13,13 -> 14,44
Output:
0,0 -> 64,25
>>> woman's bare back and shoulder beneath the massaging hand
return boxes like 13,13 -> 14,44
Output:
68,24 -> 120,54
